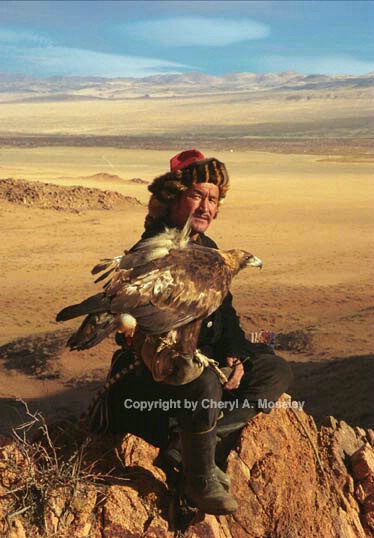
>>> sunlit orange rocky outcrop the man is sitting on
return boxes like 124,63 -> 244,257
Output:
0,400 -> 374,538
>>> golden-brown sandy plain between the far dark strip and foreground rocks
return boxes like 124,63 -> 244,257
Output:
0,147 -> 374,431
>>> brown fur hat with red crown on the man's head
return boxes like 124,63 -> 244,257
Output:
145,149 -> 229,229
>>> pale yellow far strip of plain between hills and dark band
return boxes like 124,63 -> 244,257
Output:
0,90 -> 374,136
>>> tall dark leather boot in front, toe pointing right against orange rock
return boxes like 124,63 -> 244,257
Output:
181,428 -> 238,515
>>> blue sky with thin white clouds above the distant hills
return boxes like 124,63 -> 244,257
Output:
0,0 -> 374,77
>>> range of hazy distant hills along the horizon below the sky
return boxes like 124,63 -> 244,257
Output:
0,71 -> 374,102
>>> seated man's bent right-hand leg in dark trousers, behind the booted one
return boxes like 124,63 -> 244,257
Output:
217,343 -> 293,438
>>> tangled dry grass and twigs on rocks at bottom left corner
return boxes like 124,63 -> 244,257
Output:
0,402 -> 121,538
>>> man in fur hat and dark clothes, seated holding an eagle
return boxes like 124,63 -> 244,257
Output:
95,150 -> 291,514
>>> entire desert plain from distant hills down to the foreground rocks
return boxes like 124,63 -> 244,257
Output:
0,75 -> 374,433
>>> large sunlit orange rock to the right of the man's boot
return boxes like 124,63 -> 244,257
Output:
224,404 -> 365,538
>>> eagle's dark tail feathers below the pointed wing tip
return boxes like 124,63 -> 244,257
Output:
66,312 -> 121,351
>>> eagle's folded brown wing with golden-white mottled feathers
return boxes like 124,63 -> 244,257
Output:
107,245 -> 232,334
